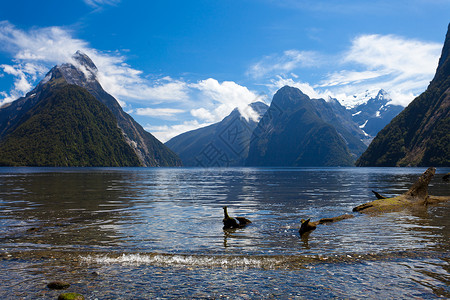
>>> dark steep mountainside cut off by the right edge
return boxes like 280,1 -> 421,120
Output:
356,24 -> 450,167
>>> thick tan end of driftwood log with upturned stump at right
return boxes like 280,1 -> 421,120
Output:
353,168 -> 450,213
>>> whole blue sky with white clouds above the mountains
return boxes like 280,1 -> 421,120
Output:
0,0 -> 450,141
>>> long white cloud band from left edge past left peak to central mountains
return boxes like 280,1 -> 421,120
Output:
0,21 -> 268,140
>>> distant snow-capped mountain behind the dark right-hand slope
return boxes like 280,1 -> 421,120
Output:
350,90 -> 403,141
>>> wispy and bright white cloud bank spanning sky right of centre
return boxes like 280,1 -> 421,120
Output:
253,34 -> 442,106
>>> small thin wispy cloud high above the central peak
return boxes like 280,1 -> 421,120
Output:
247,50 -> 320,78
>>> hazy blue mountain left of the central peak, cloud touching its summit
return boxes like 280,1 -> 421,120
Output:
166,102 -> 268,167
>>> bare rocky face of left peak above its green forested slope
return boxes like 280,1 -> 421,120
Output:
0,52 -> 181,166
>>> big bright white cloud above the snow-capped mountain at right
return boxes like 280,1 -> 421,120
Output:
319,35 -> 442,106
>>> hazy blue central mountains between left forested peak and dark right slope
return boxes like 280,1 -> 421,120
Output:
166,86 -> 404,167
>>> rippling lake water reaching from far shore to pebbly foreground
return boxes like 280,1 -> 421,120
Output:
0,168 -> 450,299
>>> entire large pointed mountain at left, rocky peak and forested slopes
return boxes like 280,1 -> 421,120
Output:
0,51 -> 181,166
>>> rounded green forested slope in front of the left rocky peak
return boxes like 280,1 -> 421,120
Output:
0,83 -> 140,167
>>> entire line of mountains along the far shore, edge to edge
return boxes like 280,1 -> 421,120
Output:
0,39 -> 442,167
